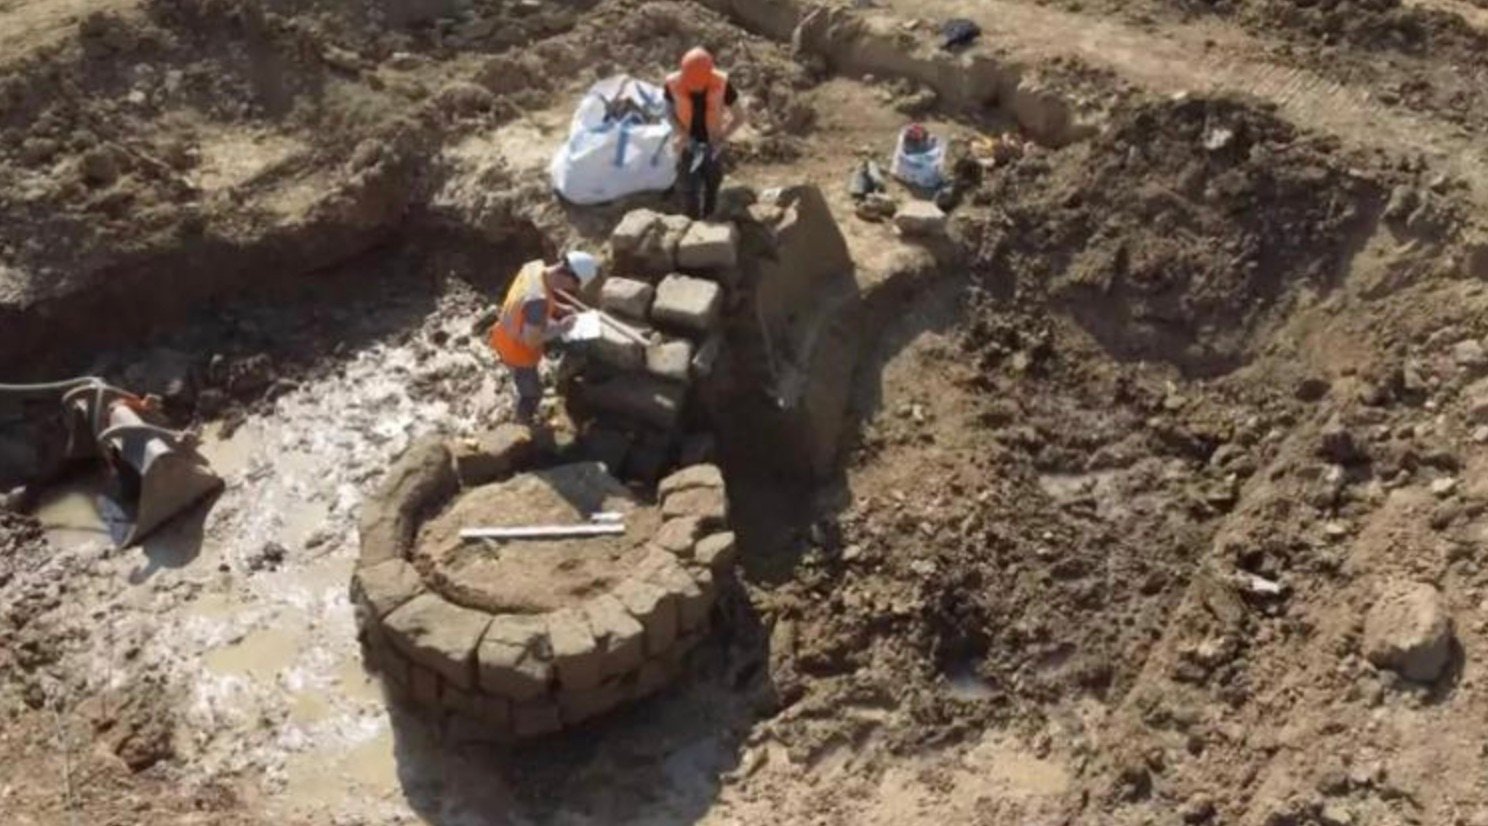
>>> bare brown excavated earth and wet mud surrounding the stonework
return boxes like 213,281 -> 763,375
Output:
0,0 -> 1488,826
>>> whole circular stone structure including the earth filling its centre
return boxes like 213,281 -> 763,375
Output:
351,426 -> 734,738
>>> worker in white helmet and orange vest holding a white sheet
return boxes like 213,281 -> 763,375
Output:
491,252 -> 600,424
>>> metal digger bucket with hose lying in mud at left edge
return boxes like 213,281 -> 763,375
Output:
0,378 -> 223,548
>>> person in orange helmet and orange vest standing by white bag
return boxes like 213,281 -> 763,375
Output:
667,46 -> 745,219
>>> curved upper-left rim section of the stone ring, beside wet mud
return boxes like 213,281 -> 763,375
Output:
359,436 -> 460,566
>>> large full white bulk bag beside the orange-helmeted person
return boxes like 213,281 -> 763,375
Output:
549,74 -> 677,204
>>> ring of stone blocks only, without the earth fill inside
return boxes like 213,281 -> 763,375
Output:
353,437 -> 734,740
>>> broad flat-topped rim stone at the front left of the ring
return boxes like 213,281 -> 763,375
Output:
385,594 -> 491,689
